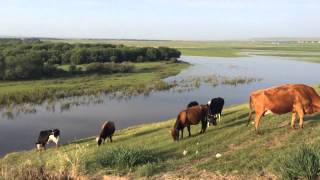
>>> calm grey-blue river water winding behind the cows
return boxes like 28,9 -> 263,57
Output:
0,56 -> 320,156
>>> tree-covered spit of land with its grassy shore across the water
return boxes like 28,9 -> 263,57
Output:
0,39 -> 188,106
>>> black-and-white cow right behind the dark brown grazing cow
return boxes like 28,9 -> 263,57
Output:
208,97 -> 224,122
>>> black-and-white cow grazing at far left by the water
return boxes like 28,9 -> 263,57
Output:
36,129 -> 60,150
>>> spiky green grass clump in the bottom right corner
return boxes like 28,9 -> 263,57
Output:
278,146 -> 320,180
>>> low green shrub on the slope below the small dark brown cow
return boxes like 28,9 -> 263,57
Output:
99,147 -> 158,169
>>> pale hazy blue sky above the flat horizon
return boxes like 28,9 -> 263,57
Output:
0,0 -> 320,40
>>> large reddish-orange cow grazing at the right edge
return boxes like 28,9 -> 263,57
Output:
248,84 -> 320,131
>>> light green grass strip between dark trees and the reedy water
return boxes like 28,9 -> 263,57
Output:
0,62 -> 189,106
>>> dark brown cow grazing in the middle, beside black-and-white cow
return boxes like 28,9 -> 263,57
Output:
171,105 -> 216,141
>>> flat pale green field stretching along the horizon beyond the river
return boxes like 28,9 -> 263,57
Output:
44,39 -> 320,62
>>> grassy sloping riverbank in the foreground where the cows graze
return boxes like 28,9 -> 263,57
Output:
0,98 -> 320,179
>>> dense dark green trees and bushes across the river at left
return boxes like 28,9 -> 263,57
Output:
0,39 -> 181,80
